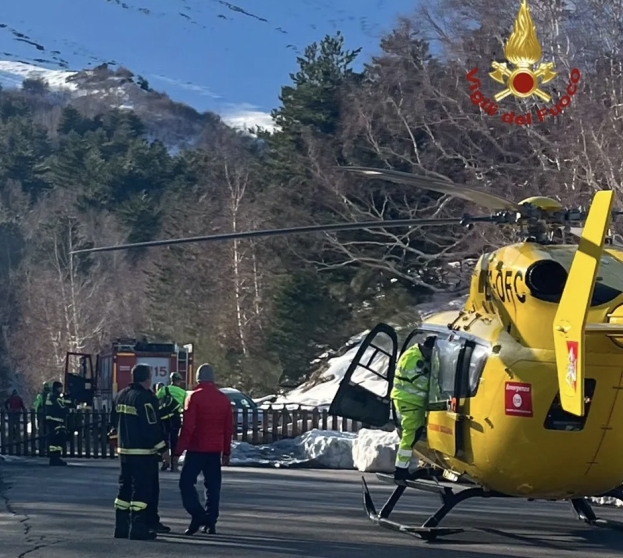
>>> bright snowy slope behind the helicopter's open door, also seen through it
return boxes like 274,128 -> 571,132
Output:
272,296 -> 466,407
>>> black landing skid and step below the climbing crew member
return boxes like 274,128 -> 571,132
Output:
361,469 -> 507,541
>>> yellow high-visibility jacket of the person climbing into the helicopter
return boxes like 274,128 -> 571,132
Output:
391,344 -> 430,408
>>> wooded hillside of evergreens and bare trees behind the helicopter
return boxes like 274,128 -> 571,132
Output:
0,0 -> 623,402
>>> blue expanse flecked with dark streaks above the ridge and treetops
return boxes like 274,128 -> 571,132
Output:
0,0 -> 416,129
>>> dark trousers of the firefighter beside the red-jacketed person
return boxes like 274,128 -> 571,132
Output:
115,455 -> 159,524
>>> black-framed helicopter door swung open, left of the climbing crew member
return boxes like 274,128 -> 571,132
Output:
329,323 -> 398,427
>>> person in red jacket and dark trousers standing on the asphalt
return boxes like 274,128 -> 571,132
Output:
175,364 -> 233,535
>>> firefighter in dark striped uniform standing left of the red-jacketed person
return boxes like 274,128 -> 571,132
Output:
110,364 -> 170,540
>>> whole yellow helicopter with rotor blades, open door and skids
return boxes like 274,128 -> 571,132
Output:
73,167 -> 623,540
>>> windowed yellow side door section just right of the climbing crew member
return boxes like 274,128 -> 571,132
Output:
426,335 -> 476,457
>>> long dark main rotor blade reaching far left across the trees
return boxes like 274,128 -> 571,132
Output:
71,217 -> 470,254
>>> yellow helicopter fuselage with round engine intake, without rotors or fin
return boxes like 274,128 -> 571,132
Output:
415,242 -> 623,499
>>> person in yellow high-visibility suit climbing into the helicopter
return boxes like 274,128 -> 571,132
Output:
391,336 -> 436,480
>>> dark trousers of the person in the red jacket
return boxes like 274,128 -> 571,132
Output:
180,451 -> 221,526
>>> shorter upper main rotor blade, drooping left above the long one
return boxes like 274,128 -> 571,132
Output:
338,167 -> 522,213
